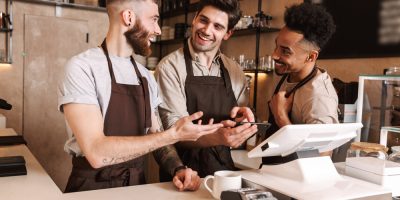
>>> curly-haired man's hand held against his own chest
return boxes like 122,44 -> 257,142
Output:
269,91 -> 293,127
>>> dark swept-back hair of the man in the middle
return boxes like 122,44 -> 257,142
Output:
198,0 -> 242,30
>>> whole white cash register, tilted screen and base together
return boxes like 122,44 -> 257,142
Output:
236,123 -> 391,200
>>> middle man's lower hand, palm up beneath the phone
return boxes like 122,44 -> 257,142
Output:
215,120 -> 258,148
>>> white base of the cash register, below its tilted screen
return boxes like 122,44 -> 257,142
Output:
239,156 -> 392,200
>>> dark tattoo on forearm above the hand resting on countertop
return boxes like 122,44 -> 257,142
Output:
153,145 -> 183,176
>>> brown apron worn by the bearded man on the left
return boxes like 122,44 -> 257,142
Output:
65,40 -> 151,192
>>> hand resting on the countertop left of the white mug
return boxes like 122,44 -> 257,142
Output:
172,168 -> 201,191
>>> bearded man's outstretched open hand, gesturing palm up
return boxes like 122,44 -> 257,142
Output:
168,112 -> 223,141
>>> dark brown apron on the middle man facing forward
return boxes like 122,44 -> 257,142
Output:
177,39 -> 237,177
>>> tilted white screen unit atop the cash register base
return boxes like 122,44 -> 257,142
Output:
248,123 -> 362,158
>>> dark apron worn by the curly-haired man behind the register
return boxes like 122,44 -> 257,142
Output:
261,66 -> 319,165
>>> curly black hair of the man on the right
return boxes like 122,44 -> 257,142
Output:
285,3 -> 336,49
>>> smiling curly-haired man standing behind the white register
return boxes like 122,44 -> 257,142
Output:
263,3 -> 338,164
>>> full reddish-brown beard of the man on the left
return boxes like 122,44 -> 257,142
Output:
124,19 -> 151,56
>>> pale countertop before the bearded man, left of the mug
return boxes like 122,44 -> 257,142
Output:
0,129 -> 216,200
